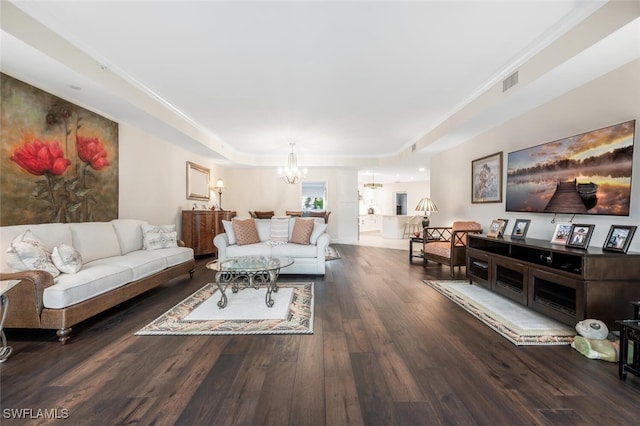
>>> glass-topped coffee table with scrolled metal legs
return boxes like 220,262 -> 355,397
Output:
206,256 -> 294,309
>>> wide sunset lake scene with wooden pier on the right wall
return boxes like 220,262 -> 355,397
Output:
506,120 -> 635,216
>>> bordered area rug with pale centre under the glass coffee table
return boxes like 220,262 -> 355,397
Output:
136,282 -> 313,336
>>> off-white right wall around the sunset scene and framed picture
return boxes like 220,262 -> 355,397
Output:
431,60 -> 640,251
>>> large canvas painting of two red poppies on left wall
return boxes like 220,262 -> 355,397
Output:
0,74 -> 118,226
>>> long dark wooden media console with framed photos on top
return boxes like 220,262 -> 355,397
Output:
467,235 -> 640,330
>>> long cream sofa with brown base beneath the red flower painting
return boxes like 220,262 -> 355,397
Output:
0,219 -> 195,344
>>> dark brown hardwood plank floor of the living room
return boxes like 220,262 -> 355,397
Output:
0,245 -> 640,426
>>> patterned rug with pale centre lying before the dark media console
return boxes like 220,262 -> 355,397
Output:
424,280 -> 576,346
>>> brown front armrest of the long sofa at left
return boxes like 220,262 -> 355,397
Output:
0,271 -> 54,328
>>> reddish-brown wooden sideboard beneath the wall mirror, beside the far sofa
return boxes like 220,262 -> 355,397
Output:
182,210 -> 236,256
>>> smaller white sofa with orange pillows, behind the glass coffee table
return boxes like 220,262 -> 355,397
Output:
213,218 -> 330,275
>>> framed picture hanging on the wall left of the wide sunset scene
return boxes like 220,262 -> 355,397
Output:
471,151 -> 502,203
